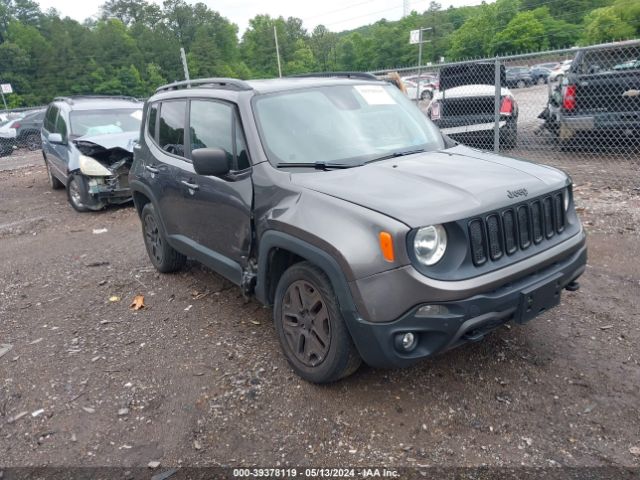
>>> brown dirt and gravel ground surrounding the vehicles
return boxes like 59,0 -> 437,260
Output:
0,160 -> 640,467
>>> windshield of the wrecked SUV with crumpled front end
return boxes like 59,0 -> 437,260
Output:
69,108 -> 142,137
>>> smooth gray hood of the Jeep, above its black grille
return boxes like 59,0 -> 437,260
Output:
291,146 -> 568,228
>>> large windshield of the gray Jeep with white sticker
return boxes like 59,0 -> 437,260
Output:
254,84 -> 444,165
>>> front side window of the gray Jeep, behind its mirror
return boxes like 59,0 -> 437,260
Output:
189,100 -> 249,170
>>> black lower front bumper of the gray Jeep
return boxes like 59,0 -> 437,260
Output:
347,233 -> 587,367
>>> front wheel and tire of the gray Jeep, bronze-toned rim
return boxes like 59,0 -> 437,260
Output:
273,262 -> 362,383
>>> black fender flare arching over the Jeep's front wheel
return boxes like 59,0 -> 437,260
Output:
254,230 -> 357,316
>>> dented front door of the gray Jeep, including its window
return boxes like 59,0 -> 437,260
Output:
176,99 -> 253,283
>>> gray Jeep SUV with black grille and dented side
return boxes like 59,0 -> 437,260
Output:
130,75 -> 587,382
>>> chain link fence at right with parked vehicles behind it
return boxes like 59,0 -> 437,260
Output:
373,40 -> 640,192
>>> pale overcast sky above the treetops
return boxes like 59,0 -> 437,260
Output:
30,0 -> 480,35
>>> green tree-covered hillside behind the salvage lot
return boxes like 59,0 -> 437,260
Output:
0,0 -> 640,106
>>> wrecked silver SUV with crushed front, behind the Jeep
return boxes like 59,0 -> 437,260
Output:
42,96 -> 143,212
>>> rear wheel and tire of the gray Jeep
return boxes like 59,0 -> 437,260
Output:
140,202 -> 187,273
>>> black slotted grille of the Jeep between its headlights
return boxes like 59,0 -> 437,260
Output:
469,192 -> 566,266
